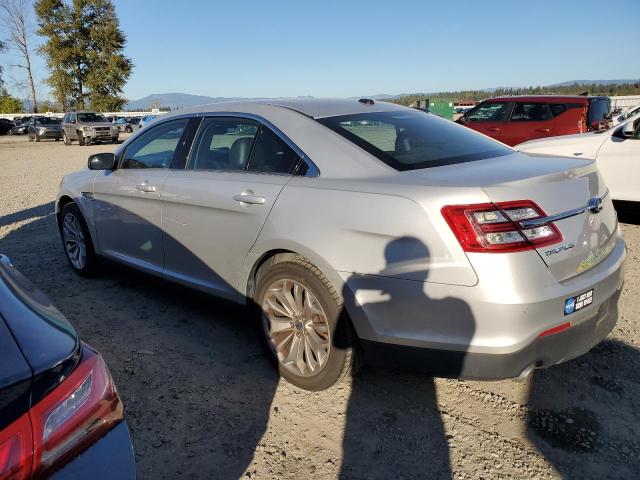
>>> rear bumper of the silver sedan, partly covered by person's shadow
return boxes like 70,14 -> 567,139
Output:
343,232 -> 626,379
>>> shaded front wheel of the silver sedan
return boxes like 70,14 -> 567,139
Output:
60,202 -> 98,277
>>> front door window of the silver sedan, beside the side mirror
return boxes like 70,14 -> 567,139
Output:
121,118 -> 189,168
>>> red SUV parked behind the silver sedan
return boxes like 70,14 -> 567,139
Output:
457,95 -> 611,146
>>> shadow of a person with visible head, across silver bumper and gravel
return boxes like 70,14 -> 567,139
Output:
340,237 -> 475,479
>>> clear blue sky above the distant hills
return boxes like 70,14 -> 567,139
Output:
0,0 -> 640,99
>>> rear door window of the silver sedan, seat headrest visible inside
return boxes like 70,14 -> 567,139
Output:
189,117 -> 260,171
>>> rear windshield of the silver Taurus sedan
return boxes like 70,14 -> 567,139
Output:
318,111 -> 512,171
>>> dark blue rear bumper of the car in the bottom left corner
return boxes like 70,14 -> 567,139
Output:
50,421 -> 136,480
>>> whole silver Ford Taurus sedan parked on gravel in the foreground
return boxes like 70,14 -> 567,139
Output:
56,99 -> 625,390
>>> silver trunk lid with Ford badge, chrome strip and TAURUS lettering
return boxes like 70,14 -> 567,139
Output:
483,155 -> 618,282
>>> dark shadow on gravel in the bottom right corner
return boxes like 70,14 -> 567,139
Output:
526,340 -> 640,479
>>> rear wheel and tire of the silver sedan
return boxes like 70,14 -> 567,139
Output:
255,256 -> 356,391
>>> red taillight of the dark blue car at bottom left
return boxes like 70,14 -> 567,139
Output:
0,347 -> 123,479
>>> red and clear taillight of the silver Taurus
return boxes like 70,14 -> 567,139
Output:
442,200 -> 562,253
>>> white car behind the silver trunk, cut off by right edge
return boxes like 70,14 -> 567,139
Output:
515,113 -> 640,202
